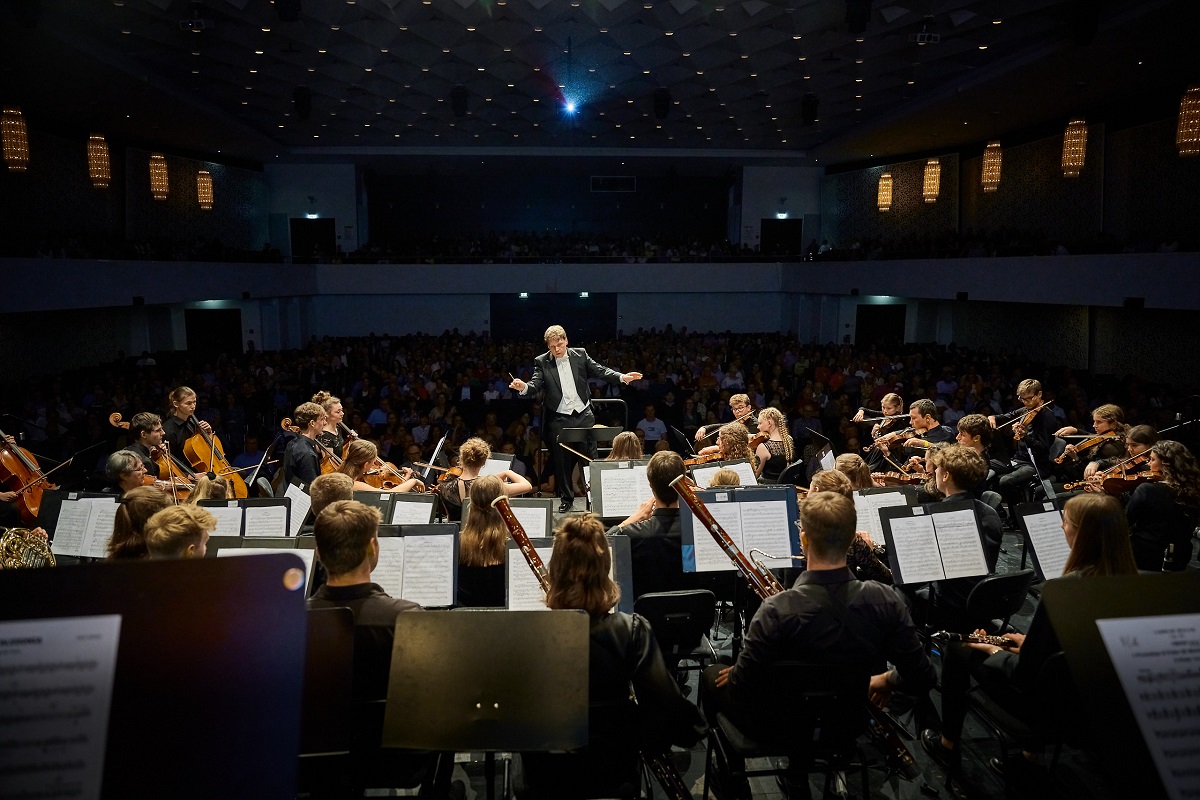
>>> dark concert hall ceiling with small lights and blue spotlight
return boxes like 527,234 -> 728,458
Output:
0,0 -> 1200,166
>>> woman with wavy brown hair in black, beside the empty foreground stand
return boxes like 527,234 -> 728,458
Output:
513,515 -> 704,800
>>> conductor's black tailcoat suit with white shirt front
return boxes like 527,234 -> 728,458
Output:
521,348 -> 623,503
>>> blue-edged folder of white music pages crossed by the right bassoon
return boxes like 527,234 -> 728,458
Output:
679,485 -> 800,572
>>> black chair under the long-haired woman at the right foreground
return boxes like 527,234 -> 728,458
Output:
967,650 -> 1084,796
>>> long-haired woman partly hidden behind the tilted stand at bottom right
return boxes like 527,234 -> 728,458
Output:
920,494 -> 1138,772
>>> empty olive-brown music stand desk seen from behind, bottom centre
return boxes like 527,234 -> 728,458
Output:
381,610 -> 588,752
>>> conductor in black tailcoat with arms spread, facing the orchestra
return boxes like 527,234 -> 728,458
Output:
509,325 -> 642,513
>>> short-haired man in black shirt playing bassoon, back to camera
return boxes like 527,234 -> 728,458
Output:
701,492 -> 934,798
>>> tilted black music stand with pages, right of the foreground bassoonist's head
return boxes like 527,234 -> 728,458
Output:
880,500 -> 988,585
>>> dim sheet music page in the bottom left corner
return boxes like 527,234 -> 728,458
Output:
0,614 -> 121,800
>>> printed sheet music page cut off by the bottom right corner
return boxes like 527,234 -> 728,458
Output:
1096,614 -> 1200,800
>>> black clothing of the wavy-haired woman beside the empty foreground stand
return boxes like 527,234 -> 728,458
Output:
516,613 -> 706,800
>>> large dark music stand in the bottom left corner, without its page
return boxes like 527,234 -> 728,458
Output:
0,553 -> 306,800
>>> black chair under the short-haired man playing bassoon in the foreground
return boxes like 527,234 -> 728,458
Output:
704,661 -> 871,800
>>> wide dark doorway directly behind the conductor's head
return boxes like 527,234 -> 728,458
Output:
492,291 -> 617,348
